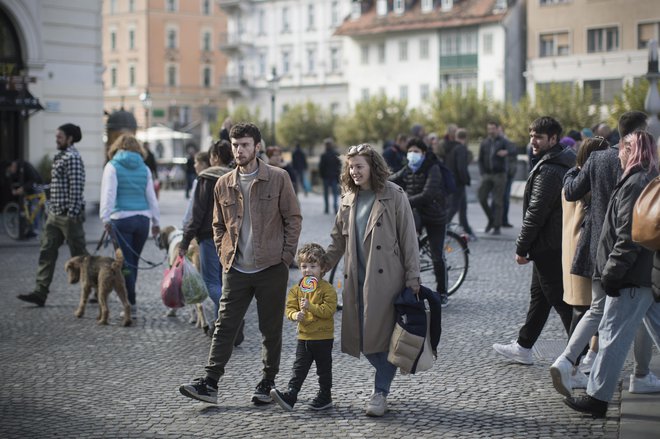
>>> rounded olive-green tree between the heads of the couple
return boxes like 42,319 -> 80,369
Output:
275,101 -> 335,153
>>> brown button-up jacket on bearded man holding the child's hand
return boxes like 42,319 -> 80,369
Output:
213,159 -> 302,272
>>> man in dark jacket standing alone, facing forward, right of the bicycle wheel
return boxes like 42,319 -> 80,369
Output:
478,121 -> 509,235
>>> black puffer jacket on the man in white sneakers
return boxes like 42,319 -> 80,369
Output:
516,144 -> 575,260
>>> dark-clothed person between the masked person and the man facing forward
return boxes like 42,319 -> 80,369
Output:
445,128 -> 475,238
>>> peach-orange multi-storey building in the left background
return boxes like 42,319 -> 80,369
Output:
103,0 -> 226,155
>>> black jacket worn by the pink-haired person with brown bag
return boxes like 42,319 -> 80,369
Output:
594,167 -> 658,296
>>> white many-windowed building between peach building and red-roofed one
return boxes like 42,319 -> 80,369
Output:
218,0 -> 351,132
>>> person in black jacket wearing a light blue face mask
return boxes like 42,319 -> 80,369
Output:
390,138 -> 447,305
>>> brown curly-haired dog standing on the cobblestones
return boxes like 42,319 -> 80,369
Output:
64,249 -> 132,326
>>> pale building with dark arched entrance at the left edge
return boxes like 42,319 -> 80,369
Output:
0,0 -> 104,205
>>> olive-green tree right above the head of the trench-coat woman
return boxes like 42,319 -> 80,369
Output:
335,93 -> 411,149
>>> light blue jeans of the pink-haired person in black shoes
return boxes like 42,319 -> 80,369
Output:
587,287 -> 660,401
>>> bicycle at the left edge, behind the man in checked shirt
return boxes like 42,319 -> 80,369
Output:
2,185 -> 50,240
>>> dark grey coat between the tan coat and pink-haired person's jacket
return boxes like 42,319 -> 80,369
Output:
564,146 -> 621,278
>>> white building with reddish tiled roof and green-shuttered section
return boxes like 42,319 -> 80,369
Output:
337,0 -> 525,107
